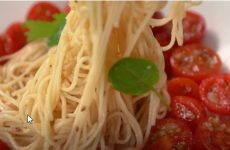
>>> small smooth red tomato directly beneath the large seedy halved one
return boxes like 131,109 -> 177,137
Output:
167,77 -> 199,98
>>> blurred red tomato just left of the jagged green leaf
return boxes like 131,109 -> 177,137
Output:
5,23 -> 27,54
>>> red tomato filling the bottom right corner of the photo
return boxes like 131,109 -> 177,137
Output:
194,117 -> 230,150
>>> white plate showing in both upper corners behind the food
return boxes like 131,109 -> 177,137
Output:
0,1 -> 230,69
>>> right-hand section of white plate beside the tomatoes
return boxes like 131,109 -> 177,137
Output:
194,1 -> 230,71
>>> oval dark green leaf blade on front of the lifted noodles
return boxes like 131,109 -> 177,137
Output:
109,57 -> 159,95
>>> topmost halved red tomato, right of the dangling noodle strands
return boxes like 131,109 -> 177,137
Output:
183,11 -> 205,44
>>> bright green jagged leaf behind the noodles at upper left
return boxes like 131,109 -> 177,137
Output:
24,13 -> 66,46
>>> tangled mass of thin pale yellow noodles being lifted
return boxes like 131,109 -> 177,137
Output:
0,1 -> 198,150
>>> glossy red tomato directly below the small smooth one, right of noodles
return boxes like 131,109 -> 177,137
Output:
171,96 -> 205,127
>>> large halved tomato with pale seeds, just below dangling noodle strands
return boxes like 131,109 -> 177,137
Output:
170,44 -> 221,82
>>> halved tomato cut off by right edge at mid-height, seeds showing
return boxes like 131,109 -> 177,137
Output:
199,74 -> 230,115
